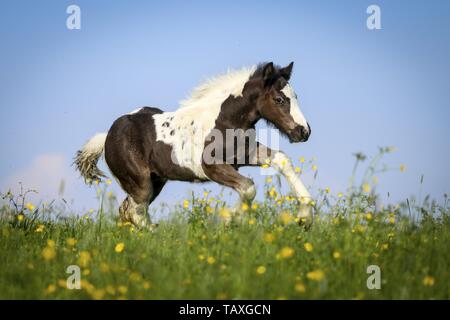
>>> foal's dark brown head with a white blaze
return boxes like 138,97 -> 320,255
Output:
256,62 -> 311,142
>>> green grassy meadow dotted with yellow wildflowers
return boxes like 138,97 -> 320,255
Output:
0,150 -> 450,299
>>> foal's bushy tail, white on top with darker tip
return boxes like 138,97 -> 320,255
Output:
74,133 -> 107,184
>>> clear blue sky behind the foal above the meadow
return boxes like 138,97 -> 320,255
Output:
0,1 -> 450,215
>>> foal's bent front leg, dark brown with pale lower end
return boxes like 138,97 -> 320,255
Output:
203,164 -> 256,219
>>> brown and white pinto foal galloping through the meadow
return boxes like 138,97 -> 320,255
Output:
75,62 -> 312,227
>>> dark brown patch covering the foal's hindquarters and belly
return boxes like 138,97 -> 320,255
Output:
105,107 -> 204,203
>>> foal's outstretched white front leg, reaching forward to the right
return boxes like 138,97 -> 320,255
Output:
254,143 -> 313,227
